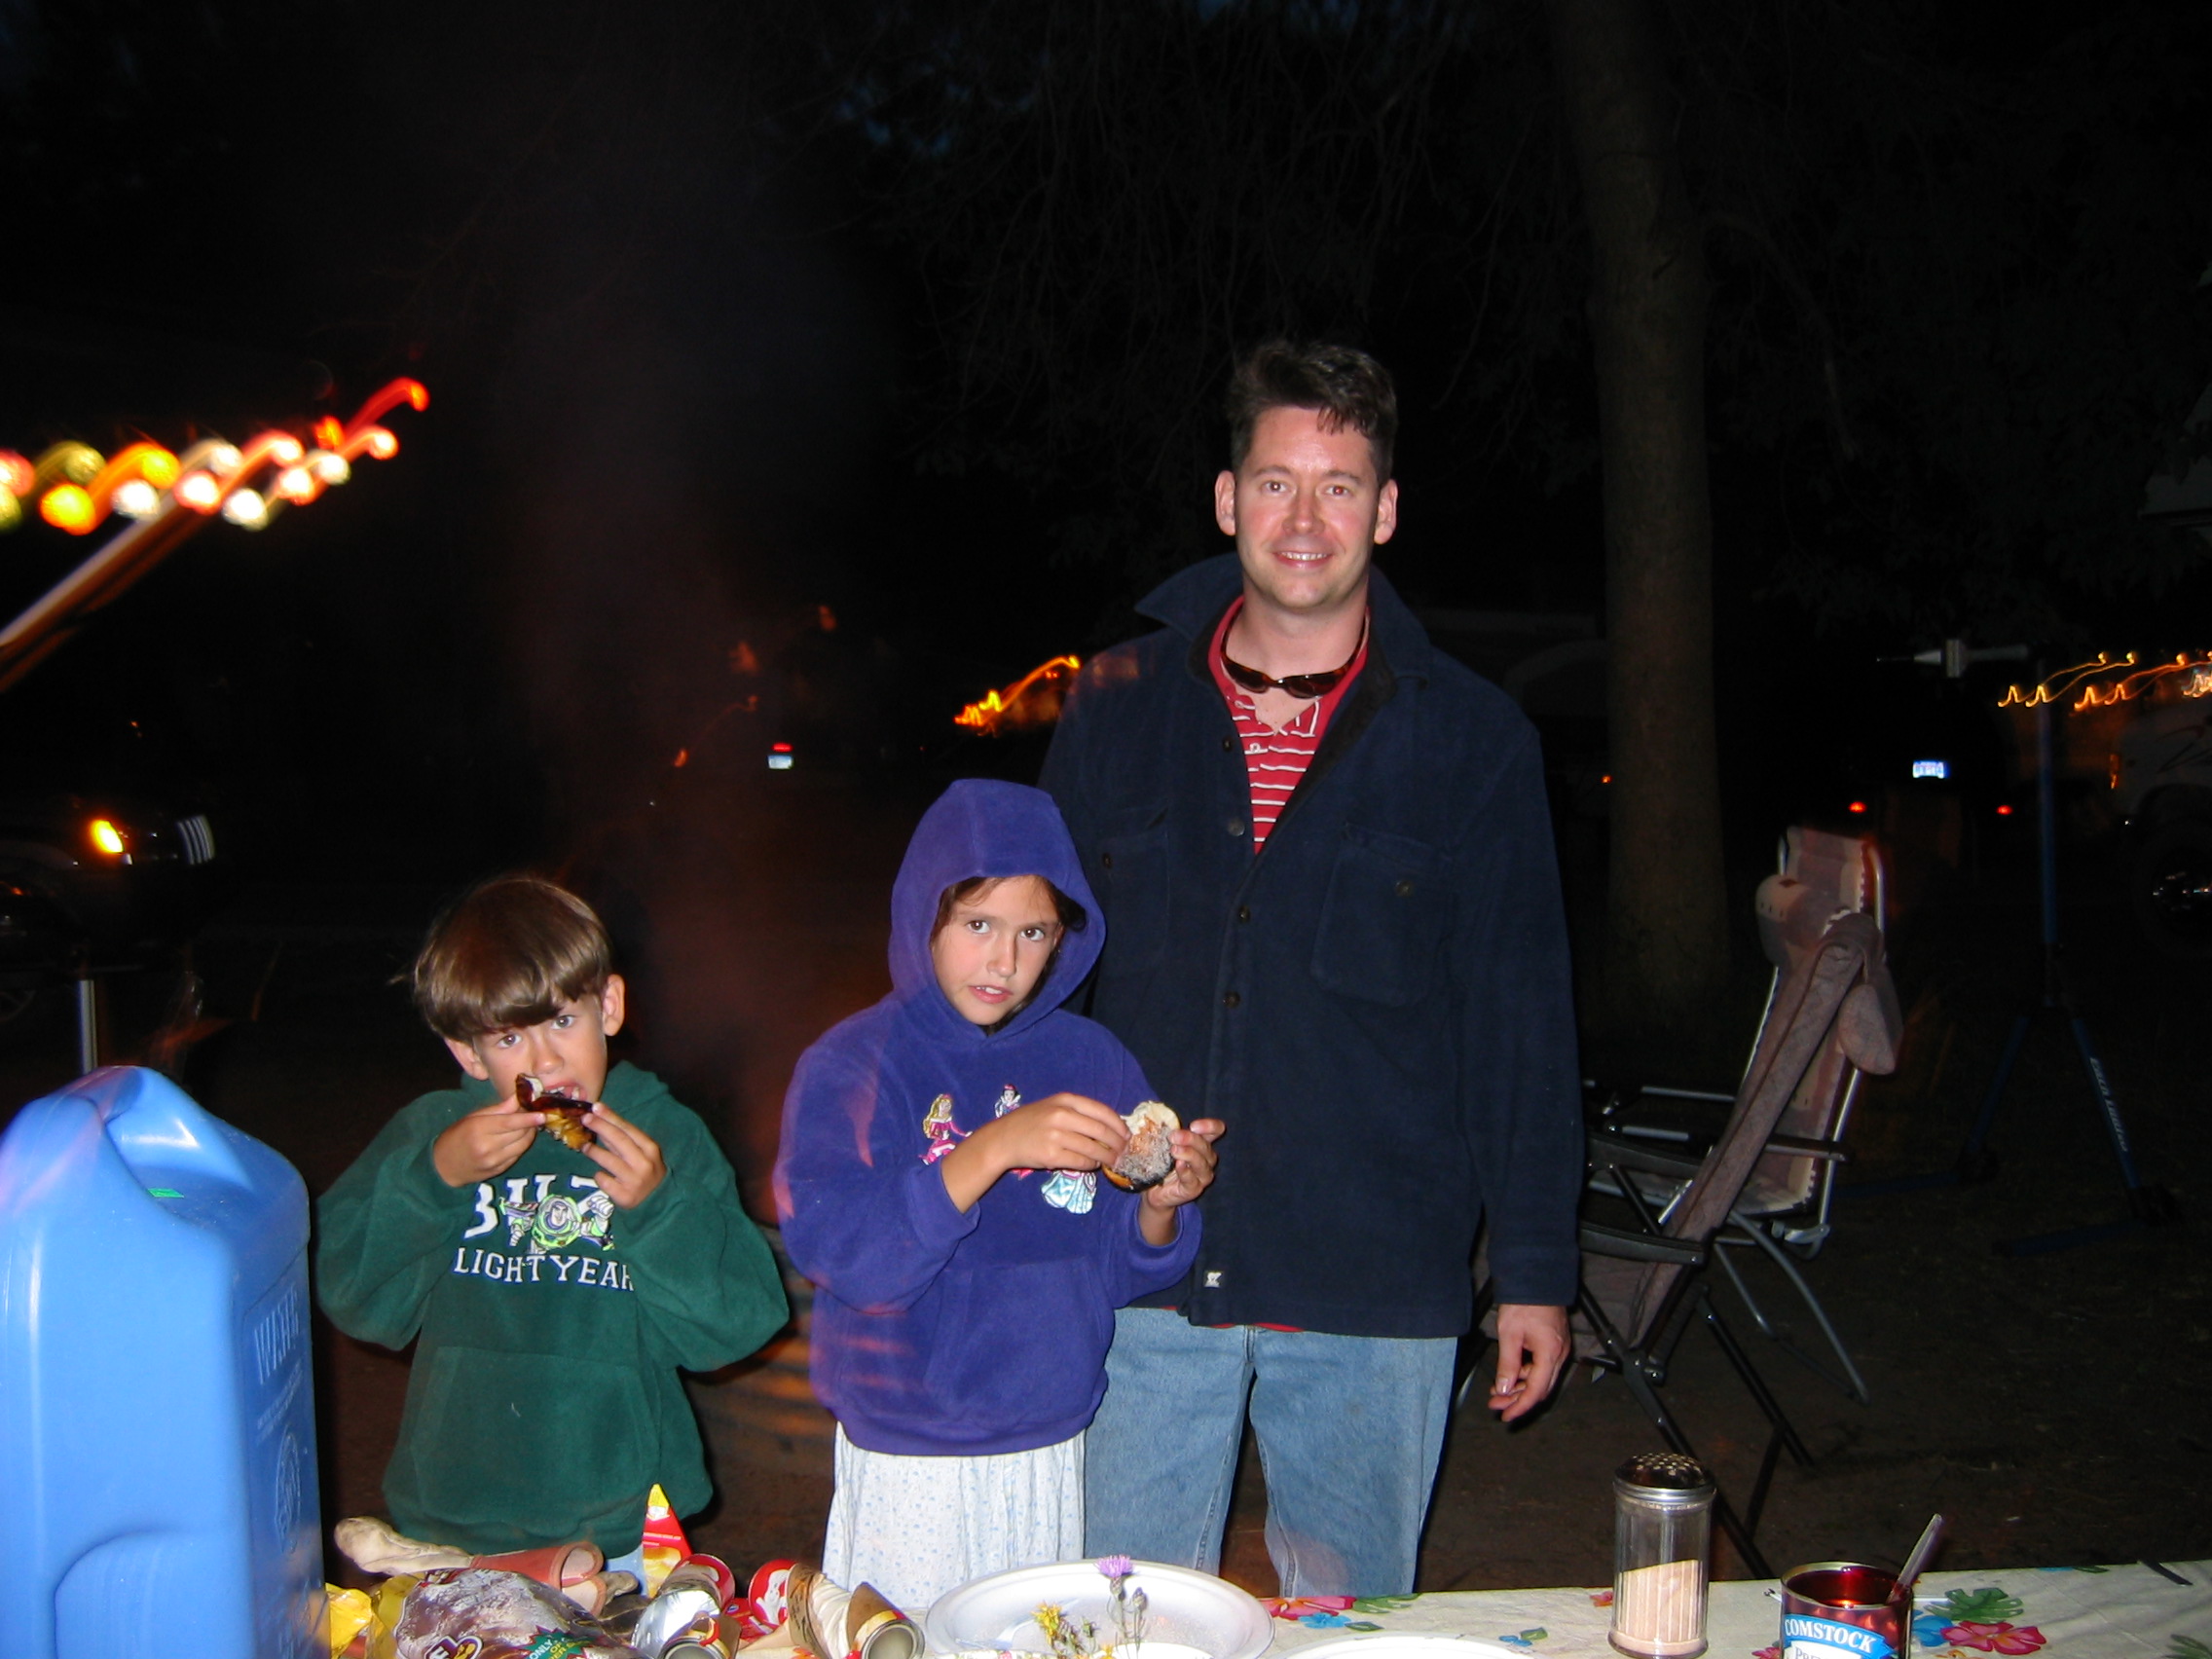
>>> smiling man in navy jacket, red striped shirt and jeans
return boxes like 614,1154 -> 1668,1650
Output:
1044,343 -> 1581,1595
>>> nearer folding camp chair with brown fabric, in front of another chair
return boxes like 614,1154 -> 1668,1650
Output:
1480,911 -> 1898,1577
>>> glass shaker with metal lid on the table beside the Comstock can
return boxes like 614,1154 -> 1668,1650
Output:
1610,1451 -> 1713,1659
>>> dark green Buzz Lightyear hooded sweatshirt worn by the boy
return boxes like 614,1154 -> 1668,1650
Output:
314,1062 -> 788,1555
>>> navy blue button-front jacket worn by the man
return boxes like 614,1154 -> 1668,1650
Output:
1044,555 -> 1581,1336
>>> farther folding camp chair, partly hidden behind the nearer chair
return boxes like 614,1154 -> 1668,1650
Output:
1597,828 -> 1894,1405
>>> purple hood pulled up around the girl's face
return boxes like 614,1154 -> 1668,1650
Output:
892,779 -> 1106,1040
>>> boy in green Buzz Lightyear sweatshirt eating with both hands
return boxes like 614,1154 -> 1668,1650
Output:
316,876 -> 786,1560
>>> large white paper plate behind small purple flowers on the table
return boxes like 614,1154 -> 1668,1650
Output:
922,1562 -> 1273,1659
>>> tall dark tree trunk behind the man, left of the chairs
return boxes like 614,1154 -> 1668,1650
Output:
1548,0 -> 1727,1026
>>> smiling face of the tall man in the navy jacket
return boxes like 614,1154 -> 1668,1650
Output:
1214,409 -> 1398,617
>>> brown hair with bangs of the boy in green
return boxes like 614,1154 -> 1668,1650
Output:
409,876 -> 615,1042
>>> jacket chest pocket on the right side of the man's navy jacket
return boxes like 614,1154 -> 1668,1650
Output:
1314,825 -> 1451,1009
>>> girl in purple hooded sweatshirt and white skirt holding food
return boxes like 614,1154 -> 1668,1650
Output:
776,781 -> 1221,1608
